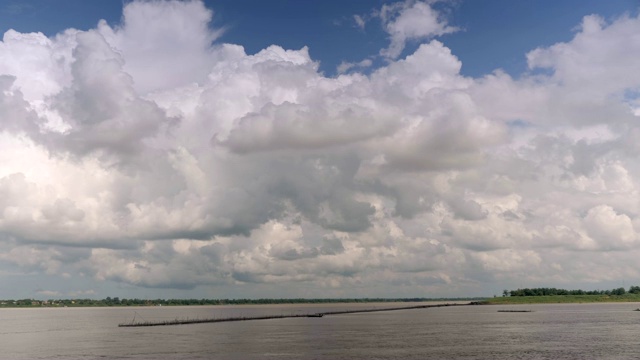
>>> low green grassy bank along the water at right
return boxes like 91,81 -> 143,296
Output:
482,294 -> 640,305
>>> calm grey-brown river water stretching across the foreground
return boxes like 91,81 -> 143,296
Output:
0,303 -> 640,360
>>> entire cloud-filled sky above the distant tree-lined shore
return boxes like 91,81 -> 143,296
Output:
0,0 -> 640,299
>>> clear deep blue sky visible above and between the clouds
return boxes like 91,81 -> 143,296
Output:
0,0 -> 640,77
